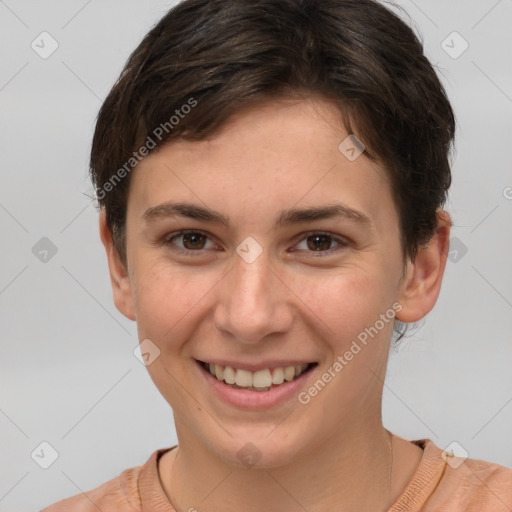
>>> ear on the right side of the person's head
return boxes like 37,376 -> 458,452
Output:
396,210 -> 452,322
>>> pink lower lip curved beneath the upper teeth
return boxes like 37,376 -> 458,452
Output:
197,361 -> 315,409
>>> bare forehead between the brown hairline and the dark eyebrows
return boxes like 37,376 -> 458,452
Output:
129,99 -> 393,232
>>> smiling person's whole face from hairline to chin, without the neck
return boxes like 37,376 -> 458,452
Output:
103,95 -> 444,467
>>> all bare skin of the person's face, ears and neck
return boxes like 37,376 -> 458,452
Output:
100,97 -> 450,512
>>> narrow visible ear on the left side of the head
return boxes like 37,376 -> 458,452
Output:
99,208 -> 136,320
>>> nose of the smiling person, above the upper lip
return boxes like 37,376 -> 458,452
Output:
214,252 -> 293,344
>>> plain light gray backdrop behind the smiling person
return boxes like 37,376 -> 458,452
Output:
0,0 -> 512,512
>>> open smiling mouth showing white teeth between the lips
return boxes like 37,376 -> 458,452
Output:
197,361 -> 318,391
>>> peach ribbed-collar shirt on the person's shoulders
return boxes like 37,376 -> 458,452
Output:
41,439 -> 512,512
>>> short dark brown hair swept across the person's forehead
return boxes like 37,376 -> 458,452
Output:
90,0 -> 455,262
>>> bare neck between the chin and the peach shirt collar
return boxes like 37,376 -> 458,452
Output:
160,424 -> 422,512
